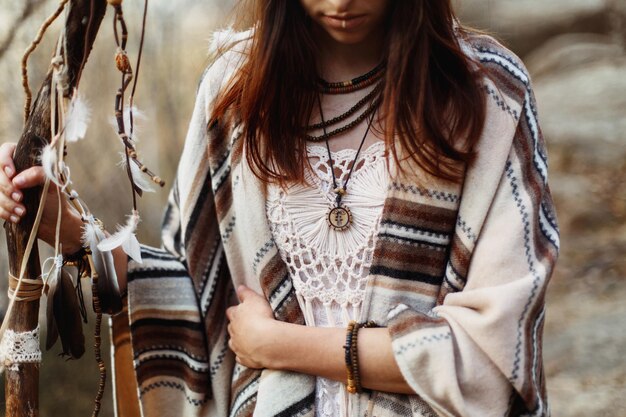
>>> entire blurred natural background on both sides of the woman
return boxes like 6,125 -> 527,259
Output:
0,0 -> 626,417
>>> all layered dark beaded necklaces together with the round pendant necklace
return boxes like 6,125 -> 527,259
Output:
305,64 -> 385,231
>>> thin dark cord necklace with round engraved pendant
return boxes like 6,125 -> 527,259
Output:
317,94 -> 376,231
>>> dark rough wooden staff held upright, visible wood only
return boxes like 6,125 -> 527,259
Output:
5,0 -> 107,417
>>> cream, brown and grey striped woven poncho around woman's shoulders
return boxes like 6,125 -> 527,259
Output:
113,30 -> 559,417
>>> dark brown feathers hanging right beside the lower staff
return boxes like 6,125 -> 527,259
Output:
46,266 -> 85,359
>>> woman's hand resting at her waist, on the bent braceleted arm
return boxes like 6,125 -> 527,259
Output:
226,285 -> 281,369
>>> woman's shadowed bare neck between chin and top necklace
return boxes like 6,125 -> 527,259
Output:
313,28 -> 384,81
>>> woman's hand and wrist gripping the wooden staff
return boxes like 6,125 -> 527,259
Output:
0,143 -> 82,254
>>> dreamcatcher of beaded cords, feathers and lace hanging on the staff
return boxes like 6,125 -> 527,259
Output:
0,0 -> 164,416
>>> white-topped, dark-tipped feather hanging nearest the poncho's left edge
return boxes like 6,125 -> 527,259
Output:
82,216 -> 122,315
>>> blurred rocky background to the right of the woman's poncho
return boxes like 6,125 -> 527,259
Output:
459,0 -> 626,417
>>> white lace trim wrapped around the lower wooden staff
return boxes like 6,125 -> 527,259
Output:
0,326 -> 41,371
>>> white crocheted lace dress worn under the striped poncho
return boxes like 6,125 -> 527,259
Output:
266,142 -> 388,417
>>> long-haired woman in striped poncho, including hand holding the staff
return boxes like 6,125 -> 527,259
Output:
0,0 -> 558,417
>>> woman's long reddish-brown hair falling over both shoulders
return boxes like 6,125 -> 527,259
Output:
212,0 -> 486,183
